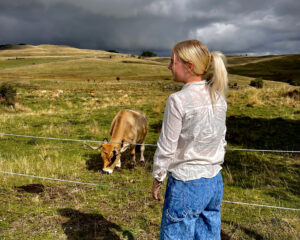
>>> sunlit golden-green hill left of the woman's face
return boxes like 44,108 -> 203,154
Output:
0,45 -> 171,82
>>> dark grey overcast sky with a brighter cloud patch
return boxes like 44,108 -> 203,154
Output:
0,0 -> 300,55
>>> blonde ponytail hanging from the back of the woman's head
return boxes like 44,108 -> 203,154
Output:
208,52 -> 228,105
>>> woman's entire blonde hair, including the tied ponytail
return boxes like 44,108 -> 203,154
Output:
173,40 -> 228,105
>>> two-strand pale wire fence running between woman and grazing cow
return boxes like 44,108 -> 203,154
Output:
0,133 -> 300,211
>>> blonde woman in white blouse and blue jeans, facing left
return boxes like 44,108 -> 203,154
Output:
152,40 -> 228,240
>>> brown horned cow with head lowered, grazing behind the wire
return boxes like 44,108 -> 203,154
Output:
85,109 -> 148,173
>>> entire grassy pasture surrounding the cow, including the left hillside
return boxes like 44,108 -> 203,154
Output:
0,45 -> 300,240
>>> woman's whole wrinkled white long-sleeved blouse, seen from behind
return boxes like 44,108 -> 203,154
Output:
152,80 -> 227,181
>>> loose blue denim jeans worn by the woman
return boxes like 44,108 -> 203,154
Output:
160,172 -> 223,240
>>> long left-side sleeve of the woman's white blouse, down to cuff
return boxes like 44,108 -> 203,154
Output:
152,94 -> 183,181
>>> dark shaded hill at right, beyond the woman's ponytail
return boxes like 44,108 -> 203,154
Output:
227,54 -> 300,86
